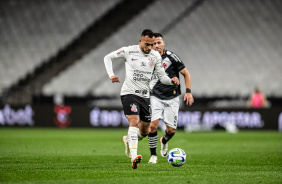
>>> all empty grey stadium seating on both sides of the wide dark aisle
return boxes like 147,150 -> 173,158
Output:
0,0 -> 282,106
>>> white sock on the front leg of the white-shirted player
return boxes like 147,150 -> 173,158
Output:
127,127 -> 139,160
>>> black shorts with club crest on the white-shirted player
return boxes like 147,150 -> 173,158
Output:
121,95 -> 151,122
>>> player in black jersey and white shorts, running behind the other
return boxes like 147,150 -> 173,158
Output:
148,33 -> 194,164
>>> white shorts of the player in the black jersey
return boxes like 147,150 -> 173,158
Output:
150,96 -> 179,129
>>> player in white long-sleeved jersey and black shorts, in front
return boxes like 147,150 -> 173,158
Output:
104,29 -> 179,169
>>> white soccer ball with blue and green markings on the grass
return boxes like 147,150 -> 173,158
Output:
167,148 -> 186,167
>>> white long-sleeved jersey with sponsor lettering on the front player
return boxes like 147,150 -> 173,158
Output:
104,45 -> 173,98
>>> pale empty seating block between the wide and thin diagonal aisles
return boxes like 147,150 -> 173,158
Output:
43,0 -> 197,96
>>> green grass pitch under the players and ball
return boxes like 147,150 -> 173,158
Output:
0,127 -> 282,184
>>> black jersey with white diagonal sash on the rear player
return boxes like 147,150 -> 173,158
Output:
150,50 -> 185,100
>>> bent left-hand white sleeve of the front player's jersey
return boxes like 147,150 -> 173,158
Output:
104,47 -> 127,77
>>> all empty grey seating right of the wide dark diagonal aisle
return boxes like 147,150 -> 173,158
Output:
43,0 -> 282,97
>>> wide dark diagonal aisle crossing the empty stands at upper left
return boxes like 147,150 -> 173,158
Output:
2,0 -> 153,103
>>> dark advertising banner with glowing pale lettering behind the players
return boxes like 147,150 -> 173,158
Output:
0,104 -> 282,131
